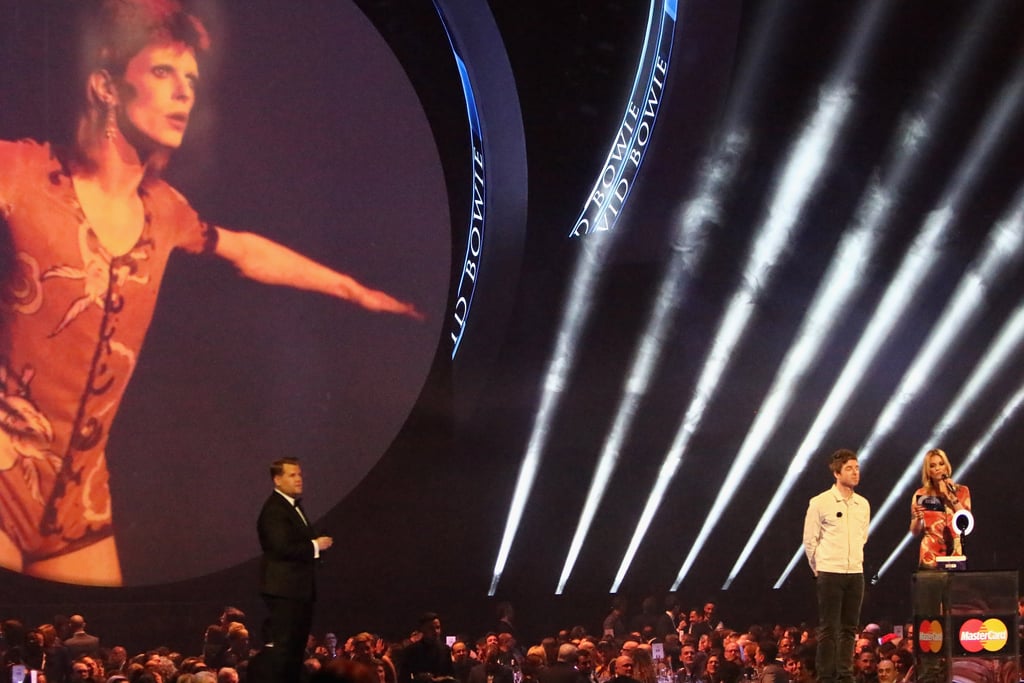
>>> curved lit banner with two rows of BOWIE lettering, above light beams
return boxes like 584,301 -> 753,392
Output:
569,0 -> 677,238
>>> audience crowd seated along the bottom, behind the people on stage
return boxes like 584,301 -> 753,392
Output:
0,598 -> 1024,683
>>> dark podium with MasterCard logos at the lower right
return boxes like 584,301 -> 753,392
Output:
910,570 -> 1020,683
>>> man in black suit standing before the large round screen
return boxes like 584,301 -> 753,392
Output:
256,458 -> 334,683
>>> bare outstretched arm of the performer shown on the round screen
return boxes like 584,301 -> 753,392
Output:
215,226 -> 423,319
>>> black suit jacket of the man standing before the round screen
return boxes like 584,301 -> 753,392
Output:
256,490 -> 316,600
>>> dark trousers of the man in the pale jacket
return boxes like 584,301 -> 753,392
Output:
814,571 -> 864,683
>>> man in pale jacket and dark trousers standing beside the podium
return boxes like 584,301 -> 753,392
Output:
804,449 -> 871,683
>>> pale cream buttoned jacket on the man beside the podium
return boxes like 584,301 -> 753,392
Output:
804,485 -> 871,577
